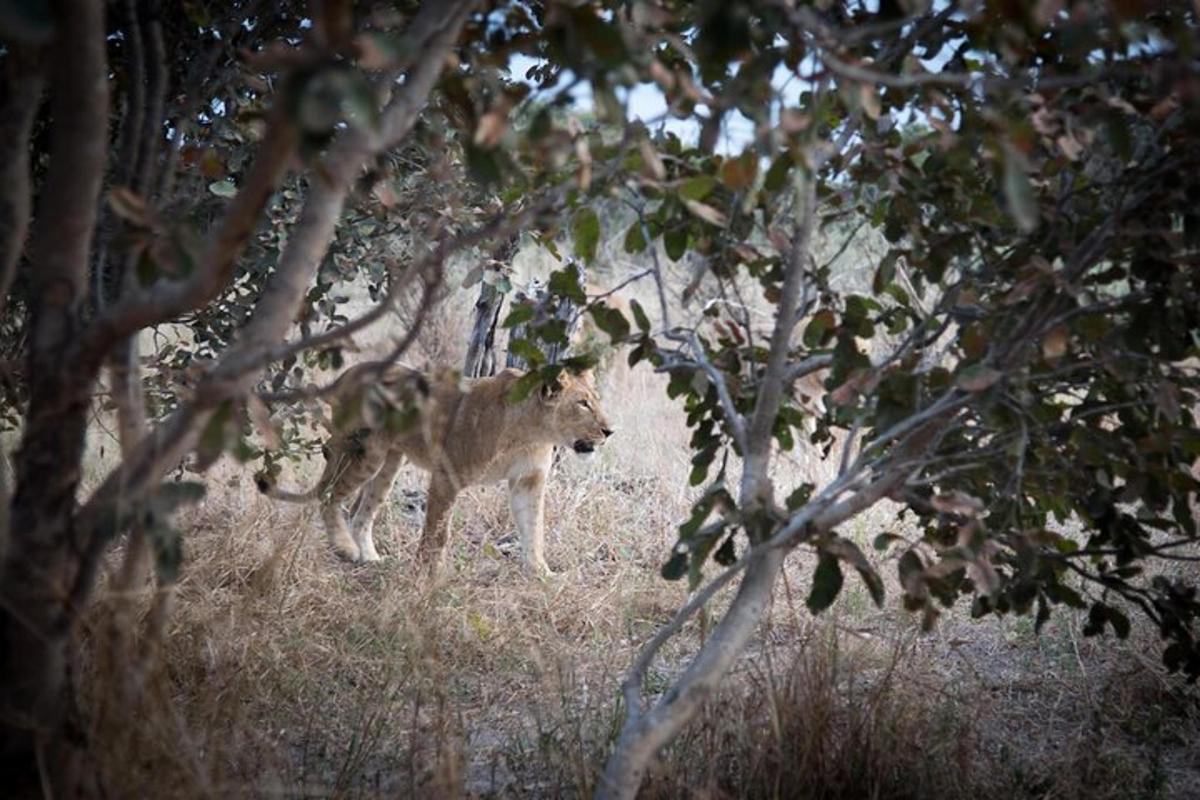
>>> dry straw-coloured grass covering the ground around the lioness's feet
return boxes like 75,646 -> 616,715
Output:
68,260 -> 1200,800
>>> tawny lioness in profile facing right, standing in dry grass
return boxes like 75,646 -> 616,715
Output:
259,363 -> 612,575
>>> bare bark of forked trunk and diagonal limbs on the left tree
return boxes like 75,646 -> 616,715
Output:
0,0 -> 476,798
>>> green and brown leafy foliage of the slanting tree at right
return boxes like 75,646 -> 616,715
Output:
494,2 -> 1200,679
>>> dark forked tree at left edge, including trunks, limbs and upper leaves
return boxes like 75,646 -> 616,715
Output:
0,1 -> 487,794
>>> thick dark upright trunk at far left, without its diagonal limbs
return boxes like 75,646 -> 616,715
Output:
0,0 -> 108,796
